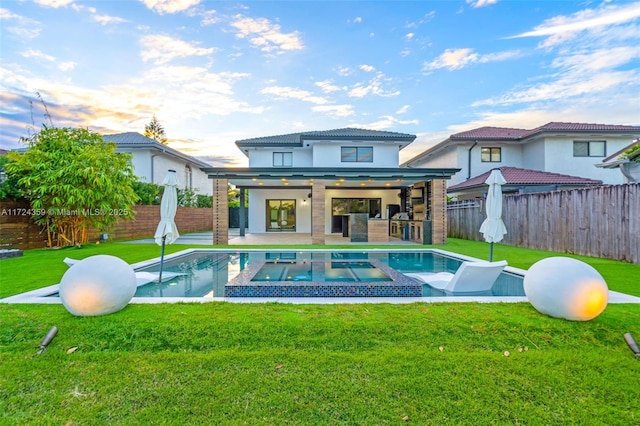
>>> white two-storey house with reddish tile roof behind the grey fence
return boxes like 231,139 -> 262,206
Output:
403,122 -> 640,186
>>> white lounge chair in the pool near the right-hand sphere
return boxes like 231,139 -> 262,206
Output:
405,260 -> 507,293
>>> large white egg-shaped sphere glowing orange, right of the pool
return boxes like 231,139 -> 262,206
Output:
524,257 -> 609,321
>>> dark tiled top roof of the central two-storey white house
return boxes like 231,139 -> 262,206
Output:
236,127 -> 416,147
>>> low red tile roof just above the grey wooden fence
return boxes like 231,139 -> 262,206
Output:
447,167 -> 602,192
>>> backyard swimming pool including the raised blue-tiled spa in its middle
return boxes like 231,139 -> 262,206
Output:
134,250 -> 525,298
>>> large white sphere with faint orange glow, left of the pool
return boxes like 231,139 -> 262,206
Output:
59,255 -> 137,316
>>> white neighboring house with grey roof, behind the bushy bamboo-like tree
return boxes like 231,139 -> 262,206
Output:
102,132 -> 212,195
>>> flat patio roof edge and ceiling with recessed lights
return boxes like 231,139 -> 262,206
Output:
201,167 -> 460,189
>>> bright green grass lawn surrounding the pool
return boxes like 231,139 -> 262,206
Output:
0,240 -> 640,425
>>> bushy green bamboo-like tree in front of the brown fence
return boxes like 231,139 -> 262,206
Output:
6,125 -> 138,246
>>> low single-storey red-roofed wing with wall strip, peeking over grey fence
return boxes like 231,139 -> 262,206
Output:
447,166 -> 602,200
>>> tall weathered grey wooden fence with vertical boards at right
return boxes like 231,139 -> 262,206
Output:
447,183 -> 640,263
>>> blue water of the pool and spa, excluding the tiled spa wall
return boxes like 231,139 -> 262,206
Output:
134,251 -> 525,298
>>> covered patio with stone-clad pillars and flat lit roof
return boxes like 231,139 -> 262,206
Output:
203,167 -> 458,245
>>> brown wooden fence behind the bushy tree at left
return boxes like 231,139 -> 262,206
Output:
0,200 -> 213,250
